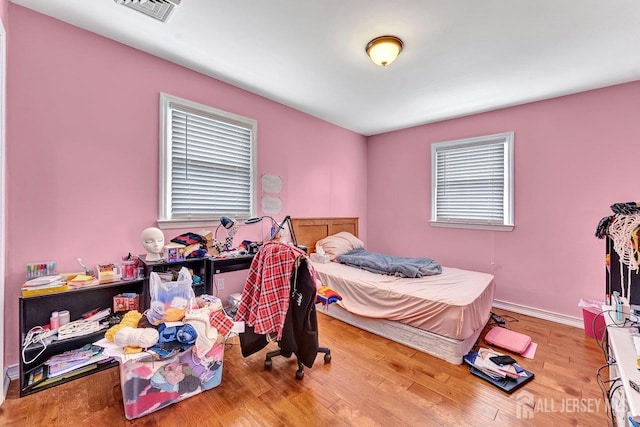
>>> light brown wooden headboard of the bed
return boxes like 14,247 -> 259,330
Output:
291,218 -> 358,254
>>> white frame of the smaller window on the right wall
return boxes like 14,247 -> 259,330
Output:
429,132 -> 515,231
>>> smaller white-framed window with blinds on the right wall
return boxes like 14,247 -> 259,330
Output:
431,132 -> 513,231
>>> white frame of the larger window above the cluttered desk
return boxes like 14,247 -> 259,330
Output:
157,93 -> 258,229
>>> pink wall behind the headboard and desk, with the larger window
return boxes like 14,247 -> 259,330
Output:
5,4 -> 366,365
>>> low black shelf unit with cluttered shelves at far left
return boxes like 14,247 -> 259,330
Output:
19,279 -> 144,396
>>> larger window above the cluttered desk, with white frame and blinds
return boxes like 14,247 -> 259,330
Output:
158,94 -> 257,228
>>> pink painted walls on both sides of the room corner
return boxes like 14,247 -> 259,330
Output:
6,0 -> 640,365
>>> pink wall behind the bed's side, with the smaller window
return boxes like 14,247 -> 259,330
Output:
367,82 -> 640,317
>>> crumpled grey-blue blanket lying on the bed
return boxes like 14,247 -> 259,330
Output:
336,249 -> 442,277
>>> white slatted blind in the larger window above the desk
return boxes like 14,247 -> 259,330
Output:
170,104 -> 253,220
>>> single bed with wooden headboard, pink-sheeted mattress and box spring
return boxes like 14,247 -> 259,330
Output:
292,218 -> 495,364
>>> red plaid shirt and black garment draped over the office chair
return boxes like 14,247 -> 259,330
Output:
235,242 -> 319,368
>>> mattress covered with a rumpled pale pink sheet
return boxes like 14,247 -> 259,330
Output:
313,262 -> 495,340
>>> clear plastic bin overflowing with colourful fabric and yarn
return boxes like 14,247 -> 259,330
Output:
105,297 -> 233,419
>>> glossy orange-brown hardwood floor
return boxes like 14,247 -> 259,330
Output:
0,310 -> 610,426
